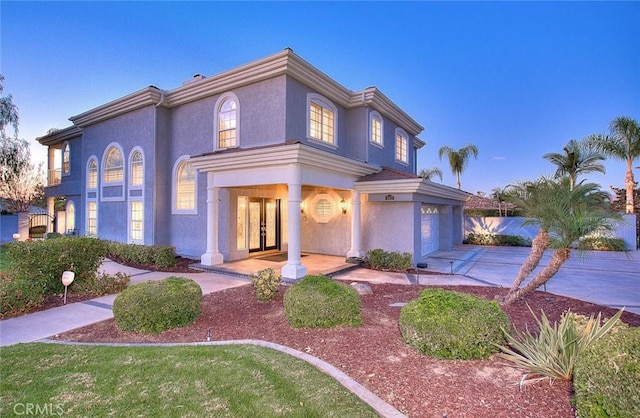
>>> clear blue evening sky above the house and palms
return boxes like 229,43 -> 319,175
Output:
0,1 -> 640,193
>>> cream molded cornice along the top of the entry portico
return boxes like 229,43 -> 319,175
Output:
189,143 -> 380,178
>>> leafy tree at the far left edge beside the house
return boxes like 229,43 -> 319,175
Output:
0,75 -> 44,212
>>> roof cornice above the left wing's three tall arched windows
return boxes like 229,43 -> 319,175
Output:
69,86 -> 164,128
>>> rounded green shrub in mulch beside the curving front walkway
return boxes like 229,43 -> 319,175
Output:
113,277 -> 202,334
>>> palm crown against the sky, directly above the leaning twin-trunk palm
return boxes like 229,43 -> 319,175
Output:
543,139 -> 605,189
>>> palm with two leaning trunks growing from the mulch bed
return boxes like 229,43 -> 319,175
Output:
503,177 -> 620,305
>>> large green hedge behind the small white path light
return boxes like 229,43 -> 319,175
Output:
6,237 -> 106,294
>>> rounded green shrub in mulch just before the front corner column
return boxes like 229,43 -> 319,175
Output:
284,275 -> 362,328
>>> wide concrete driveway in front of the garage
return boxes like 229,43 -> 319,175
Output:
421,245 -> 640,314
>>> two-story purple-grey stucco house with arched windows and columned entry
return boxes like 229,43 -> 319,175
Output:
38,49 -> 468,279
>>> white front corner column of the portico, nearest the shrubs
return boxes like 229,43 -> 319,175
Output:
282,166 -> 307,280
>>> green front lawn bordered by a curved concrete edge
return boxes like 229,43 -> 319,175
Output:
0,343 -> 377,417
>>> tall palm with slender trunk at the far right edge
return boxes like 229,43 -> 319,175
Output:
589,116 -> 640,213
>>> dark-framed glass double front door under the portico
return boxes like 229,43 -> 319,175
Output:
249,197 -> 280,252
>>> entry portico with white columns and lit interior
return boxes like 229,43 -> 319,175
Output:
190,141 -> 381,280
